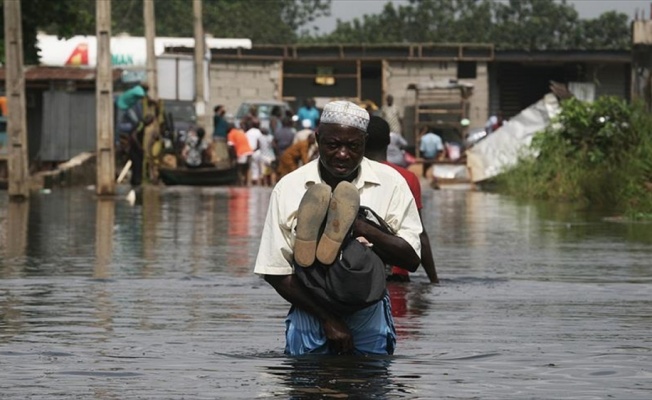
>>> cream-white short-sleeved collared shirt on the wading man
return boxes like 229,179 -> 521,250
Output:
254,158 -> 423,275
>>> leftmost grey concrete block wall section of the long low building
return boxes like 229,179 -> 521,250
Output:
209,60 -> 283,115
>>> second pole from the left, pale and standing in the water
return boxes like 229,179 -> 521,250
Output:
95,0 -> 115,196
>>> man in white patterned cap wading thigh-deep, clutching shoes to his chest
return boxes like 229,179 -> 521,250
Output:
254,101 -> 422,355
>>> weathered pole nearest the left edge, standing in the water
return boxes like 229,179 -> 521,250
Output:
4,0 -> 29,200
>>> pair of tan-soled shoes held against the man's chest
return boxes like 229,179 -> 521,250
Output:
294,181 -> 360,267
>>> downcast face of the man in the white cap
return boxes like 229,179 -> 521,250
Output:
317,124 -> 366,178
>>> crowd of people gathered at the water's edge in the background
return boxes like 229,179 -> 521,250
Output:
116,83 -> 458,197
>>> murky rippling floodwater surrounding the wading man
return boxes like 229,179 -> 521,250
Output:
0,187 -> 652,399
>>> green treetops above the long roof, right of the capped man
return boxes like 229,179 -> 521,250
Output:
316,0 -> 630,50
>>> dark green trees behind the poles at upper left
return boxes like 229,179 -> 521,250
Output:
0,0 -> 331,64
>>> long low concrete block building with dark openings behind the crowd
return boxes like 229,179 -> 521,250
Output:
196,43 -> 632,147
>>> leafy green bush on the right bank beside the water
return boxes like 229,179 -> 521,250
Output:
497,97 -> 652,217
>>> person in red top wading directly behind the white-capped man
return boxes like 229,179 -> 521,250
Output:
365,115 -> 439,283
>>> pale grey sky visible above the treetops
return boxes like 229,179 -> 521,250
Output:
314,0 -> 652,34
